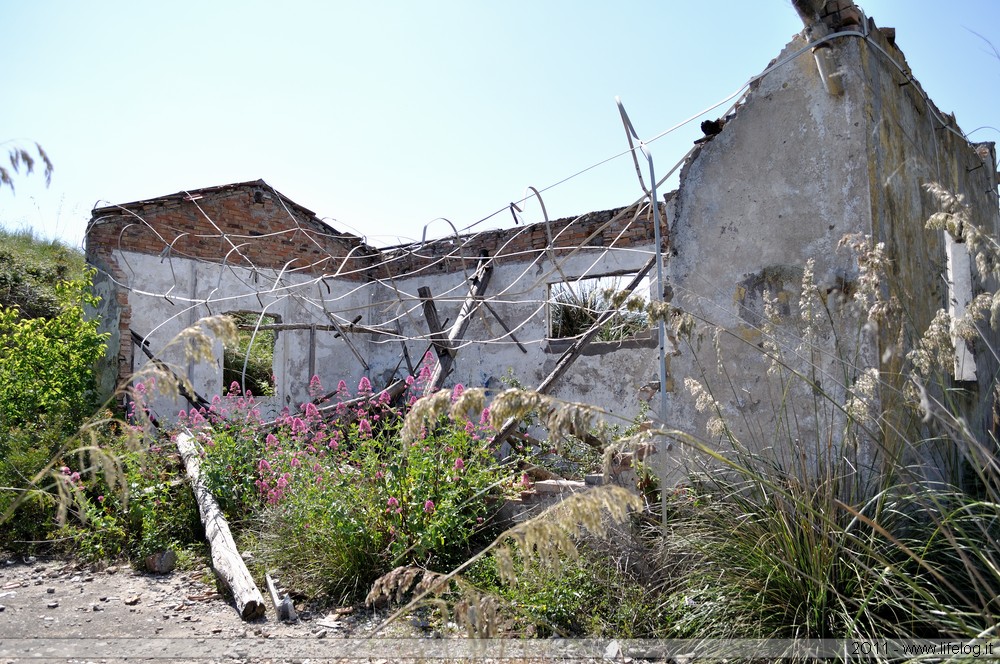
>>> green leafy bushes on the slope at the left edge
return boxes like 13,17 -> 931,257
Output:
0,233 -> 105,542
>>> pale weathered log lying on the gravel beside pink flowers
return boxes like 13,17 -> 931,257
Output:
177,432 -> 265,620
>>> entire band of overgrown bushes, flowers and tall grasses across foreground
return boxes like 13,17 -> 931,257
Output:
0,183 -> 1000,652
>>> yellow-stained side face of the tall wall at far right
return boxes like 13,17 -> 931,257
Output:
859,24 -> 1000,465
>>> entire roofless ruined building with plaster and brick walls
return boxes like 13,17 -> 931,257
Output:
87,3 -> 1000,486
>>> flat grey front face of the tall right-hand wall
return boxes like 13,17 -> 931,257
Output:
668,29 -> 870,472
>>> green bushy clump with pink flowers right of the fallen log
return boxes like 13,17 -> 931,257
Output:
185,365 -> 505,600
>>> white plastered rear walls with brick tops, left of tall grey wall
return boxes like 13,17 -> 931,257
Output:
89,197 -> 666,426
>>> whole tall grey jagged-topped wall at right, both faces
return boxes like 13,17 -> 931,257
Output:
667,25 -> 996,480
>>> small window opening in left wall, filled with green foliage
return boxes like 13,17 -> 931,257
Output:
222,311 -> 280,397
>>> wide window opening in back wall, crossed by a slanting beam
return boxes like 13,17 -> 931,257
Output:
548,274 -> 650,341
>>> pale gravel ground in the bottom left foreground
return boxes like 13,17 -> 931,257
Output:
0,558 -> 622,664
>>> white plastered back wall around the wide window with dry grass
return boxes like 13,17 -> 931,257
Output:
370,241 -> 657,420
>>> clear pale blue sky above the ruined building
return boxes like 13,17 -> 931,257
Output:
0,0 -> 1000,245
